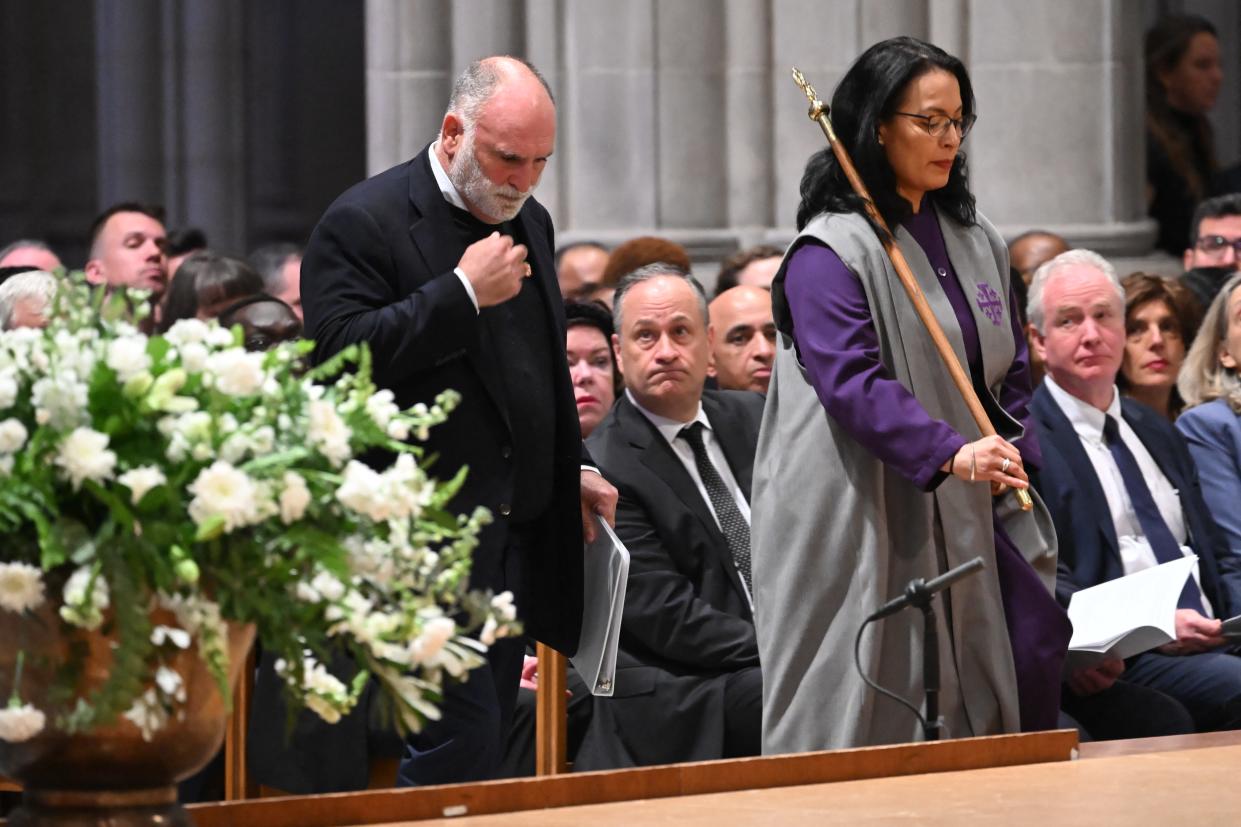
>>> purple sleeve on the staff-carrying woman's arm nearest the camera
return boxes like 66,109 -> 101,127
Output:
784,242 -> 965,490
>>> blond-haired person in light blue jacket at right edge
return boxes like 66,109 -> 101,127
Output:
1176,273 -> 1241,555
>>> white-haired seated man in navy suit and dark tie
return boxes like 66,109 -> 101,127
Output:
1029,250 -> 1241,730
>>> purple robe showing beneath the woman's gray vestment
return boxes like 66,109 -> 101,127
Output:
784,205 -> 1072,731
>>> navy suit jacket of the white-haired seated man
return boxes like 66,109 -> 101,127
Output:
1030,385 -> 1241,617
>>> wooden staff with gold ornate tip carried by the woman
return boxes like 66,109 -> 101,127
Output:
793,67 -> 1034,512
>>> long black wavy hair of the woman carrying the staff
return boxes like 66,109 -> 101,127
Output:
797,37 -> 977,235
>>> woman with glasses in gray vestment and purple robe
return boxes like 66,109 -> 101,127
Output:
752,37 -> 1070,754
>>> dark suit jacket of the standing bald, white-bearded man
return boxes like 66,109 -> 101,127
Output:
256,148 -> 588,792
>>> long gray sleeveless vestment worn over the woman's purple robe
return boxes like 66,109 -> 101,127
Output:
752,214 -> 1056,754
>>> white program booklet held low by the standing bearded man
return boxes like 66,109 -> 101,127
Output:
571,514 -> 629,698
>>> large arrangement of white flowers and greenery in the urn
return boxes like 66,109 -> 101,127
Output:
0,276 -> 519,743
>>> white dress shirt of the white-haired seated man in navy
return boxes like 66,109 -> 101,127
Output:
1044,375 -> 1212,608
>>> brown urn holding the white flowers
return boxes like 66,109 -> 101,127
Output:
0,603 -> 254,827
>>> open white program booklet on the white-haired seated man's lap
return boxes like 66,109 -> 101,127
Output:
1065,555 -> 1198,676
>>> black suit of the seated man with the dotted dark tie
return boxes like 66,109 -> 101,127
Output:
576,391 -> 763,769
